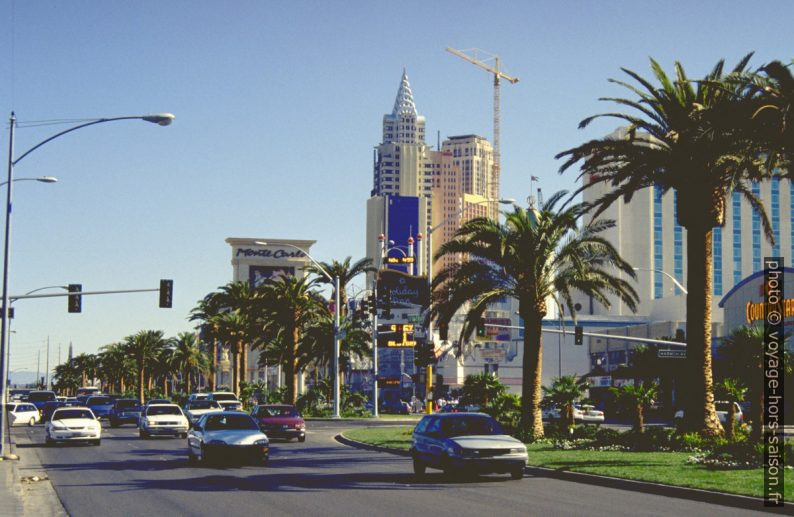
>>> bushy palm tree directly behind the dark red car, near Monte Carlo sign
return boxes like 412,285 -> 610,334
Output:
256,277 -> 328,404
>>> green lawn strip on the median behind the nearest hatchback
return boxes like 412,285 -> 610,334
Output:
344,425 -> 794,501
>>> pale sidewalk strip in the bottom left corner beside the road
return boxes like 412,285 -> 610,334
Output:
0,426 -> 68,517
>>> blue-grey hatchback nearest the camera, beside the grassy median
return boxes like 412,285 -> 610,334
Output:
411,413 -> 528,479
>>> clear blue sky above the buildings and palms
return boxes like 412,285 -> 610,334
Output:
0,0 -> 794,370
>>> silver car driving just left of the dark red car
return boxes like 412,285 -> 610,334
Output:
187,411 -> 270,463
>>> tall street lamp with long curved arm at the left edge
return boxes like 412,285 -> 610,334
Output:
0,111 -> 174,456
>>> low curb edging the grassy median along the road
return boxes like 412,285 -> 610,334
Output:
334,434 -> 794,515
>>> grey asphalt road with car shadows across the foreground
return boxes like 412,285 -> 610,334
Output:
12,421 -> 772,517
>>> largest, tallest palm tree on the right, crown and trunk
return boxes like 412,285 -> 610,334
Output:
557,54 -> 772,436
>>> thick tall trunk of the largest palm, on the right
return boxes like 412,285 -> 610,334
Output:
684,223 -> 723,436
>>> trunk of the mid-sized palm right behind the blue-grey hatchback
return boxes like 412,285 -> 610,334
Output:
521,311 -> 543,438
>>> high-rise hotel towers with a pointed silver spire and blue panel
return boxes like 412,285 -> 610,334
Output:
367,70 -> 499,274
